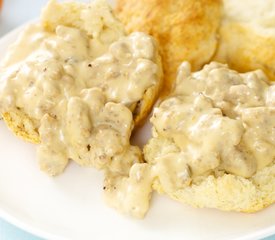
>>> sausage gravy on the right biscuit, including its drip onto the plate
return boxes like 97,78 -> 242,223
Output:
105,63 -> 275,217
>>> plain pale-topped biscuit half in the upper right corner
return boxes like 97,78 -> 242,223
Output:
214,0 -> 275,80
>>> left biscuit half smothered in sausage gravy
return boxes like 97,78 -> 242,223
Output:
0,0 -> 162,175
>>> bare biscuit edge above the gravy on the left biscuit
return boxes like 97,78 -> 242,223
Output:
41,0 -> 124,42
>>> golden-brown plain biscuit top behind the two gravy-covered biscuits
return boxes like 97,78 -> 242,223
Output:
116,0 -> 222,93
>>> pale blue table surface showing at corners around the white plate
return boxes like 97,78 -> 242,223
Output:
0,0 -> 275,240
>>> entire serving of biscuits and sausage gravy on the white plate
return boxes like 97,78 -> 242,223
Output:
0,0 -> 275,227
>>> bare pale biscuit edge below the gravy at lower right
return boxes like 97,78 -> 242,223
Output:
144,139 -> 275,213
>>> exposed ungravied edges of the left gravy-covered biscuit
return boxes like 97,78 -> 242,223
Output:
3,0 -> 163,146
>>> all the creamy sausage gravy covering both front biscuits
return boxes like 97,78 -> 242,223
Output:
0,1 -> 275,217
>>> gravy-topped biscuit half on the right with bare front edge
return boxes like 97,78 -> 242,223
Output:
144,62 -> 275,212
